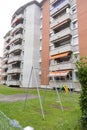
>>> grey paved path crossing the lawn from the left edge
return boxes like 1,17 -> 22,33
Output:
0,94 -> 38,102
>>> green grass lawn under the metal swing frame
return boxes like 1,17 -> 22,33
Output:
0,86 -> 80,130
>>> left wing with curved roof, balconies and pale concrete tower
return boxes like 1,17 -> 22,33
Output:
2,1 -> 41,87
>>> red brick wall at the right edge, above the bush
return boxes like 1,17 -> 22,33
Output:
77,0 -> 87,57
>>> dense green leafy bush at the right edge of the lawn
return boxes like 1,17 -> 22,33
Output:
76,57 -> 87,130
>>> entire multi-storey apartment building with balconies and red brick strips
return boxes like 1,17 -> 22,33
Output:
3,0 -> 87,89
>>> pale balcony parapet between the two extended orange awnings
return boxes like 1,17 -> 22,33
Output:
50,61 -> 74,71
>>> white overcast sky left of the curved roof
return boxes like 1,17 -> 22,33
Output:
0,0 -> 41,57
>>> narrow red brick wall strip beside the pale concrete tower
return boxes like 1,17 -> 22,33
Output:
41,0 -> 50,85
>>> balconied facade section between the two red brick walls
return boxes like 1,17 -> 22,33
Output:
49,0 -> 79,89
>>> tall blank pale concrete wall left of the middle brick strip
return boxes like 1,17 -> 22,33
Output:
22,4 -> 40,87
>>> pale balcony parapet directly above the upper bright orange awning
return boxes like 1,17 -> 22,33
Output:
50,44 -> 73,55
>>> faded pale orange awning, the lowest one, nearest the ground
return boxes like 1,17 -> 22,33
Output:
49,70 -> 70,77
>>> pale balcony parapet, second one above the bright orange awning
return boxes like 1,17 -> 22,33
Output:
50,28 -> 72,42
